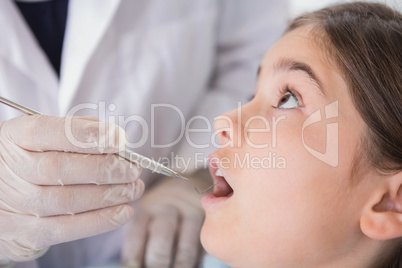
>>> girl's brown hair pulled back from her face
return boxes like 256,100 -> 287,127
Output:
286,2 -> 402,267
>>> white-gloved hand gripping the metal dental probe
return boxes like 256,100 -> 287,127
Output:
0,115 -> 144,264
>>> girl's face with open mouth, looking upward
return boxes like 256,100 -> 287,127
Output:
201,28 -> 371,267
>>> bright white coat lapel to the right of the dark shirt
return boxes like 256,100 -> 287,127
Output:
59,0 -> 121,114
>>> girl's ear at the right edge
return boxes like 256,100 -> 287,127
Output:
360,171 -> 402,240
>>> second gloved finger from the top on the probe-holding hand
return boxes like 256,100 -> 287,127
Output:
3,149 -> 141,185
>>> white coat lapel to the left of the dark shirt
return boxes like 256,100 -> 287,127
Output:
0,0 -> 58,95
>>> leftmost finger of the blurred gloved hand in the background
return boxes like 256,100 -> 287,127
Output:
122,210 -> 151,268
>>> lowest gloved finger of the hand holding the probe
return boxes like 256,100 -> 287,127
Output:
0,204 -> 134,261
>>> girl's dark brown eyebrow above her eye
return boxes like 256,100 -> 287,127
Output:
257,58 -> 325,96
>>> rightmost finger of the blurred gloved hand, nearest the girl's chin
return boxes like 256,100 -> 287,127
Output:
173,215 -> 203,268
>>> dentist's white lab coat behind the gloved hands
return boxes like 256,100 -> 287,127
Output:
0,0 -> 287,268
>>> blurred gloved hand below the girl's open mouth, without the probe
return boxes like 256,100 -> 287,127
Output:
122,172 -> 211,268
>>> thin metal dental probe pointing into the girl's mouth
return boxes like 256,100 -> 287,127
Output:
0,97 -> 215,194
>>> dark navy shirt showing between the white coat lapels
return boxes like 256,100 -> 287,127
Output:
15,0 -> 68,76
